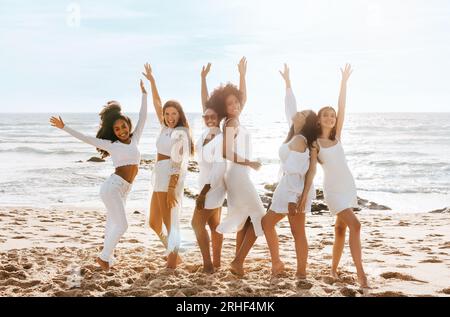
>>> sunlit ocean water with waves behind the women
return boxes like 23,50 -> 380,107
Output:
0,113 -> 450,212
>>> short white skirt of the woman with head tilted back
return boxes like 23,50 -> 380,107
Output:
270,174 -> 316,214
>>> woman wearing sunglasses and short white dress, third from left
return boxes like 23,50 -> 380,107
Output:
191,63 -> 226,273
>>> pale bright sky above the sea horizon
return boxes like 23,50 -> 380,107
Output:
0,0 -> 450,115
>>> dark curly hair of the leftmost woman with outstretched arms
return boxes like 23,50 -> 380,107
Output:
97,101 -> 133,158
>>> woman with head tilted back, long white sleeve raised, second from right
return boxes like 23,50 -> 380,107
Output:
262,64 -> 318,279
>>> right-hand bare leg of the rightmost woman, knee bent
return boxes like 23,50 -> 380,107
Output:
338,209 -> 369,288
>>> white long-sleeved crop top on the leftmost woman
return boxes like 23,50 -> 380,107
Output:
63,94 -> 147,168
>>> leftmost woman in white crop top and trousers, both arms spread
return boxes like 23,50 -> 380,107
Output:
50,68 -> 147,270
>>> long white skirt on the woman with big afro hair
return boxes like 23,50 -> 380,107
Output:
216,162 -> 266,236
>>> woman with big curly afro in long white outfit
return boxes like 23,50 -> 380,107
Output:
211,58 -> 265,276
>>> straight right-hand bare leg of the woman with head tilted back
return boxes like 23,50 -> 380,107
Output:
289,212 -> 308,279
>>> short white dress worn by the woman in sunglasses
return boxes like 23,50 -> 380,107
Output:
195,129 -> 227,209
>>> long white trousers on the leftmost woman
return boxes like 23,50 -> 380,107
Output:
99,174 -> 131,266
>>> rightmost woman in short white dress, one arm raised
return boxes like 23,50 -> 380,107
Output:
301,64 -> 368,288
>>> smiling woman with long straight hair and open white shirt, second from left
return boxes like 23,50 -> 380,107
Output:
144,65 -> 194,269
